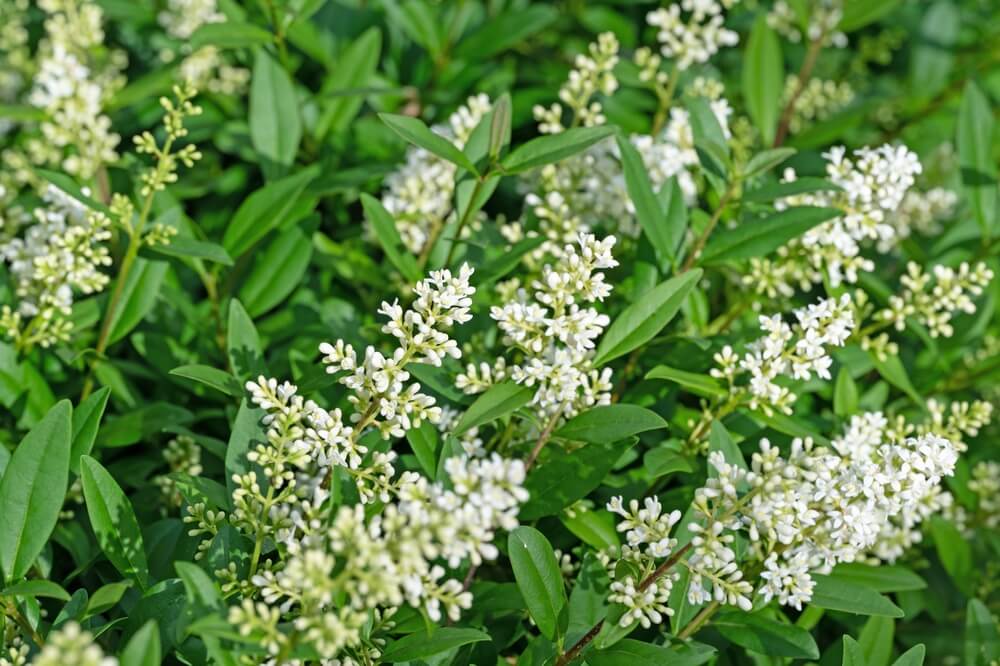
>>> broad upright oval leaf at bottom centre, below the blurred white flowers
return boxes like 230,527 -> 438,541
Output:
507,525 -> 566,640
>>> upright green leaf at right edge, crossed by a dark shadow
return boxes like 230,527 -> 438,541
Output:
956,81 -> 997,238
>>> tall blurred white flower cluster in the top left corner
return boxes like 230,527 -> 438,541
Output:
28,0 -> 125,180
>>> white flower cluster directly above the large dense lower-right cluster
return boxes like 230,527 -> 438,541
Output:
710,294 -> 855,414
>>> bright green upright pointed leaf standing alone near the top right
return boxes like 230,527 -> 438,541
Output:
743,13 -> 785,146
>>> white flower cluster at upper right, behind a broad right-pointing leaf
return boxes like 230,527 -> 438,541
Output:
743,145 -> 921,297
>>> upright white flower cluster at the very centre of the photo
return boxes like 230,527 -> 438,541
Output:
456,234 -> 618,419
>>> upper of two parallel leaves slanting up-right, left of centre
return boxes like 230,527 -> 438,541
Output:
222,165 -> 320,257
